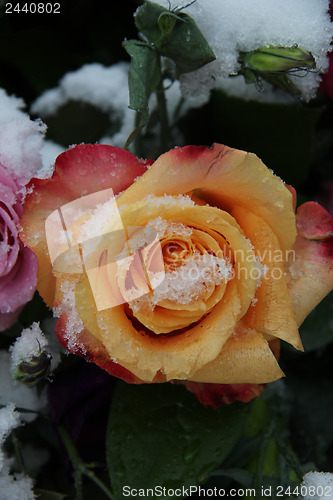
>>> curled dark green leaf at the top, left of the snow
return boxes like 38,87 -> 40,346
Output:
135,1 -> 215,75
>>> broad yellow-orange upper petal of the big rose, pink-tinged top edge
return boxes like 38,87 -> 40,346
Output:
119,144 -> 296,254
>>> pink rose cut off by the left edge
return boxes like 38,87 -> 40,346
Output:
0,164 -> 37,331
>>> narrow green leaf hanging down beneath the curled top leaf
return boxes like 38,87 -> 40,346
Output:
123,40 -> 161,127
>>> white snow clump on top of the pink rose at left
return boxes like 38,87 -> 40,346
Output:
0,89 -> 46,185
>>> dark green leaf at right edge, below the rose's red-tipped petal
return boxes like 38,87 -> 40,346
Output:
300,293 -> 333,352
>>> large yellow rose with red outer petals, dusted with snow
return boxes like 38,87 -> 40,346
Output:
21,144 -> 333,405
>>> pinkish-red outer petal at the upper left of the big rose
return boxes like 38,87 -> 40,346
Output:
21,144 -> 151,307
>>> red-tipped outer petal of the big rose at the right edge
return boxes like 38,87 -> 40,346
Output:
287,202 -> 333,325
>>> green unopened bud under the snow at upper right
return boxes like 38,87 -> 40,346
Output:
239,45 -> 316,95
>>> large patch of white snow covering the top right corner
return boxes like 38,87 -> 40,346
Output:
151,0 -> 333,99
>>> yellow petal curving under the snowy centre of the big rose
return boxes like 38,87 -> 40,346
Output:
73,275 -> 240,382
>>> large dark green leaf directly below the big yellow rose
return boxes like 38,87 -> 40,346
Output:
106,383 -> 245,499
